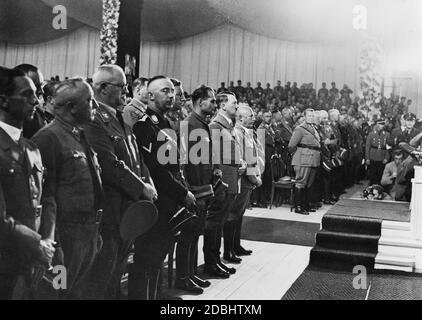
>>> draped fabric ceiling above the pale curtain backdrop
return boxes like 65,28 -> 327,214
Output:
0,0 -> 422,44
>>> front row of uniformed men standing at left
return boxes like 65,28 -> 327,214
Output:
0,66 -> 263,300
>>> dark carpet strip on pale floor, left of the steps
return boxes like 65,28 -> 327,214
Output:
242,217 -> 320,247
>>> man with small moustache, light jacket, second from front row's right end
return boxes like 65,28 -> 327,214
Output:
204,92 -> 246,278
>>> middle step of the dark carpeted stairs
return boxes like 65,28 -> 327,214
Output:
316,230 -> 379,253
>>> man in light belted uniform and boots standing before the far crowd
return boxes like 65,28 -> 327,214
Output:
289,109 -> 321,215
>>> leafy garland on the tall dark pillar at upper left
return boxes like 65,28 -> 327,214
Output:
100,0 -> 120,65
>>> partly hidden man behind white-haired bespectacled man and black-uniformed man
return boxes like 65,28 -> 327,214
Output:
123,78 -> 148,128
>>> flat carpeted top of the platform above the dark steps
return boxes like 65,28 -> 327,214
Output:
327,199 -> 410,222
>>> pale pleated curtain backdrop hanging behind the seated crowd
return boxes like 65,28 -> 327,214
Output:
0,25 -> 422,116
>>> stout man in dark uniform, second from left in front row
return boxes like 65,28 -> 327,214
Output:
32,78 -> 104,299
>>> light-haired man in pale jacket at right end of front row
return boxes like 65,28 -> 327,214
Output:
223,105 -> 262,263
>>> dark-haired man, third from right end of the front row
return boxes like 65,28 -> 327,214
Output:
176,86 -> 218,293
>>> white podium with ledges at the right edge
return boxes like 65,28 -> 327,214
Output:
375,166 -> 422,273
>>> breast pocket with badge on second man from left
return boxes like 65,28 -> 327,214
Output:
60,150 -> 89,181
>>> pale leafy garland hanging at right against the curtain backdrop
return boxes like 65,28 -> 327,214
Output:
359,36 -> 384,95
